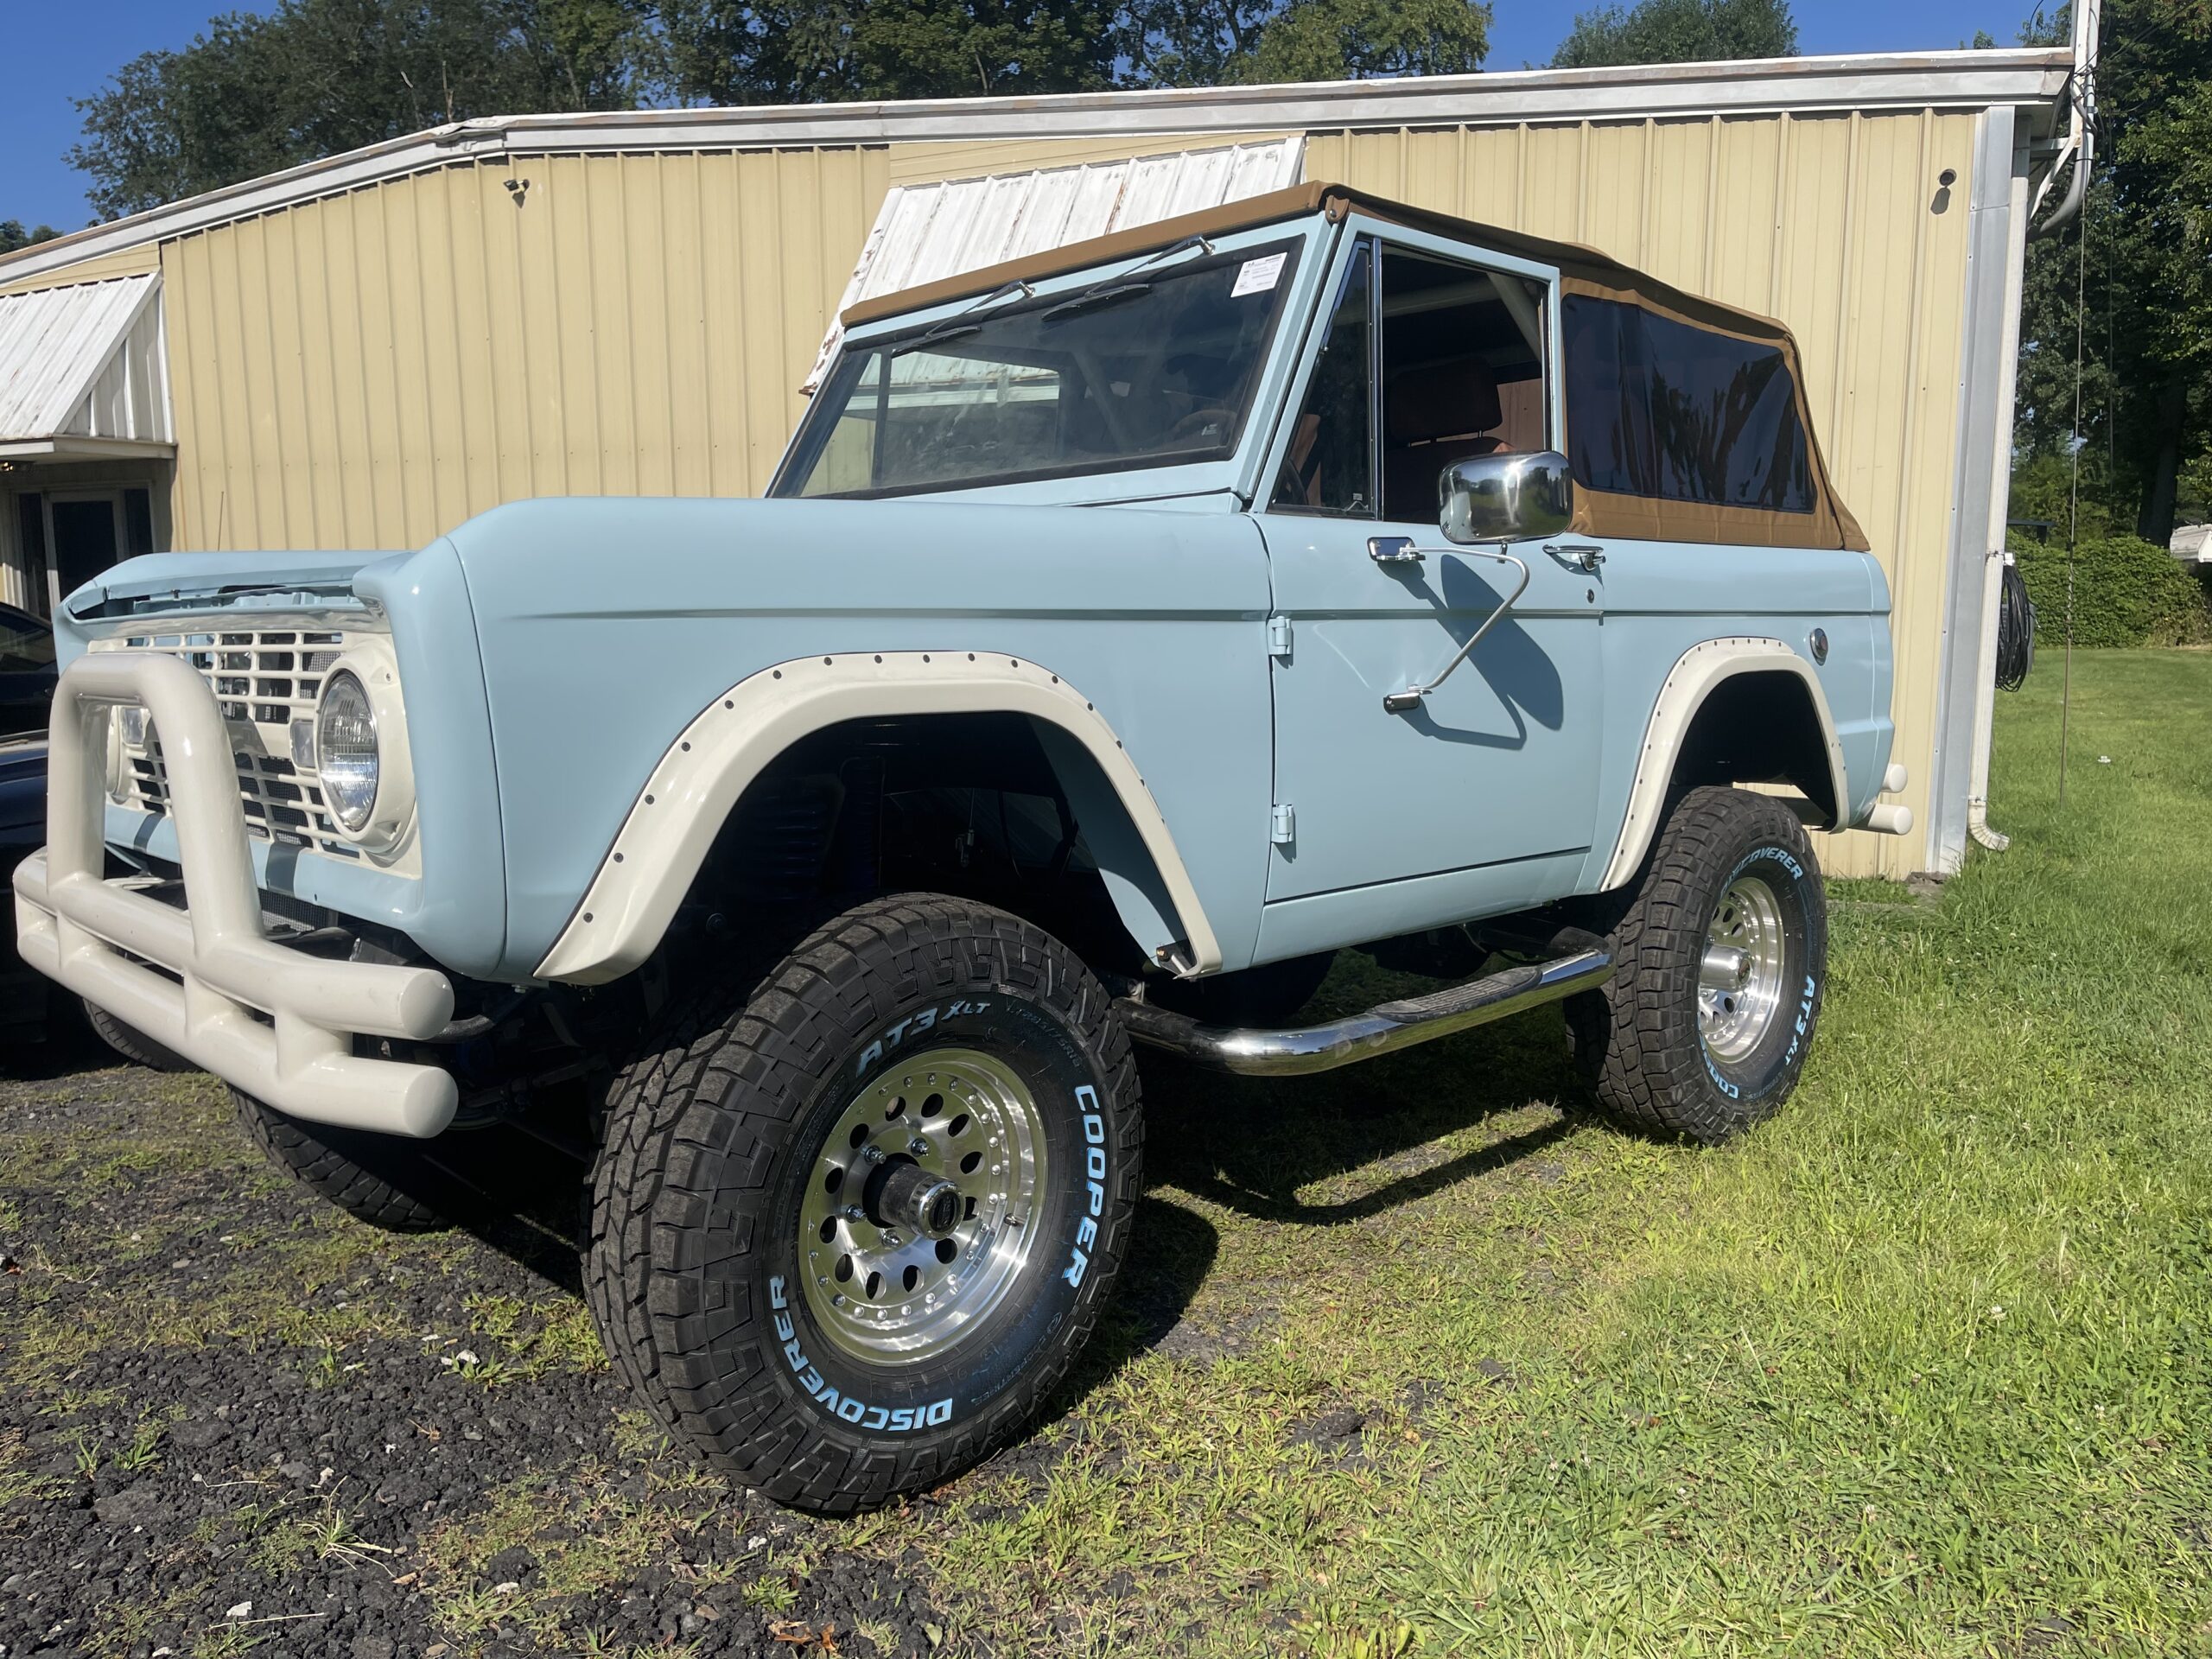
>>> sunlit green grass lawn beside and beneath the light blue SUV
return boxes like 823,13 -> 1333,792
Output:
885,652 -> 2212,1656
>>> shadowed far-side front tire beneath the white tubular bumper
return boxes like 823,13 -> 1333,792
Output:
230,1089 -> 511,1232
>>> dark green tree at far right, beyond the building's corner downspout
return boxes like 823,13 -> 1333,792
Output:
2015,0 -> 2212,546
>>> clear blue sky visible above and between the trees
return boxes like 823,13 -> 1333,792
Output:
0,0 -> 2033,230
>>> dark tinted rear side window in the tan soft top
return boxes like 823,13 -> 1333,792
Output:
1561,294 -> 1812,513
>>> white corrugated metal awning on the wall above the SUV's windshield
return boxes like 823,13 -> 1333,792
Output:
801,135 -> 1305,391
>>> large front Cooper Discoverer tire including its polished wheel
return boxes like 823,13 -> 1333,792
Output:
584,896 -> 1144,1513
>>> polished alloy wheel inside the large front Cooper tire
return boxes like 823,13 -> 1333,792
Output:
798,1048 -> 1046,1363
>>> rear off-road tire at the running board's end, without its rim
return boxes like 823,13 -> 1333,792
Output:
1566,787 -> 1827,1144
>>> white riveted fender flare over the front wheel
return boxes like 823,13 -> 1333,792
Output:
536,651 -> 1221,984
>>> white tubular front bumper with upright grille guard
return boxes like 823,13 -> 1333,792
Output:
16,651 -> 458,1137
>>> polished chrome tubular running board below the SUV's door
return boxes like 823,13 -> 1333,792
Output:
1117,936 -> 1612,1077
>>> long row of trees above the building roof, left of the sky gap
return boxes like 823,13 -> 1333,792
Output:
68,0 -> 1486,217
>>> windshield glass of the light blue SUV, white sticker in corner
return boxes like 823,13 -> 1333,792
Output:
770,244 -> 1296,495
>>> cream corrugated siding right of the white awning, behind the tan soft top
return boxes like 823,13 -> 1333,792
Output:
1305,111 -> 1975,876
